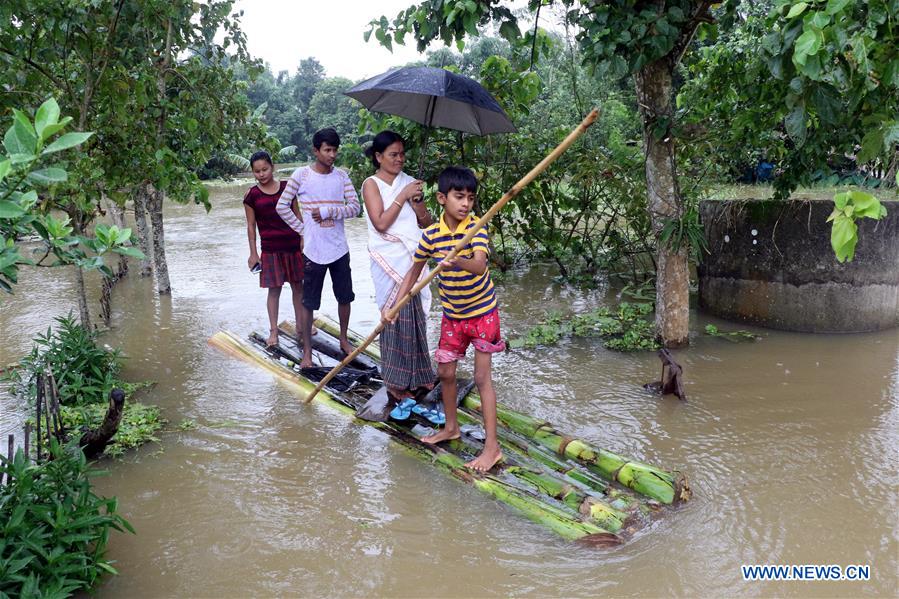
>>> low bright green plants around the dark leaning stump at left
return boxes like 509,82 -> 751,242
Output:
60,401 -> 166,457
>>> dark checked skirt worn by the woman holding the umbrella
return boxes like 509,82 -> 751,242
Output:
381,295 -> 437,395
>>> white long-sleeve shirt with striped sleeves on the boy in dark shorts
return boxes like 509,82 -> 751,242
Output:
276,166 -> 362,264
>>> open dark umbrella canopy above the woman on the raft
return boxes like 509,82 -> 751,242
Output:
344,67 -> 516,135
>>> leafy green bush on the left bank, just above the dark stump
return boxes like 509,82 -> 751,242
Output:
4,315 -> 122,407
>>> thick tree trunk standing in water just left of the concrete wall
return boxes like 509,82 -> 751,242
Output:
635,58 -> 690,347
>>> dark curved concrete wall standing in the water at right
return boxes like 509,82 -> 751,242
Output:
699,200 -> 899,333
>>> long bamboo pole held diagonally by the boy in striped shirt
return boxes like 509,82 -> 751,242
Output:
306,108 -> 599,403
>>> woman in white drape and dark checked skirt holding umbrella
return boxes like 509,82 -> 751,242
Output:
362,131 -> 437,400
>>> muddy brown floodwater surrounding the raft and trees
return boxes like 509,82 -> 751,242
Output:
0,185 -> 899,597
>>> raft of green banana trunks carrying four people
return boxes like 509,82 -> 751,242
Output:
209,317 -> 690,545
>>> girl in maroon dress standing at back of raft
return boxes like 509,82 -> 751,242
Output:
243,151 -> 303,346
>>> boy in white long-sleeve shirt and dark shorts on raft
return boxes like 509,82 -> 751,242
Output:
277,128 -> 362,368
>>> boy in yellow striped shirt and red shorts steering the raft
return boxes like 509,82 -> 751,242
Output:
382,167 -> 505,472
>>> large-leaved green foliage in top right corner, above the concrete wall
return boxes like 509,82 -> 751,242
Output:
678,0 -> 899,197
